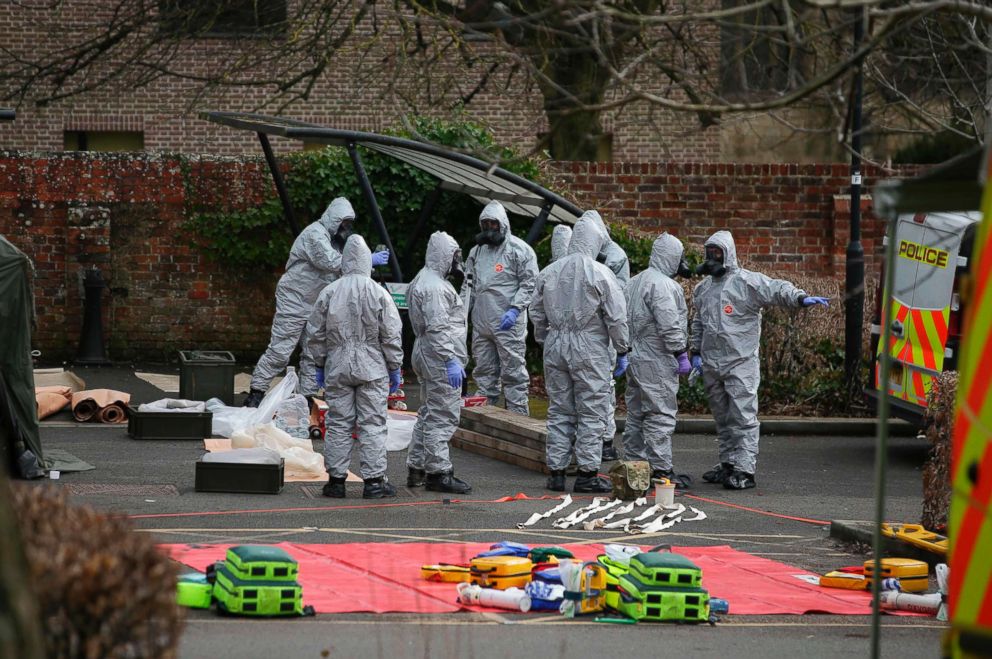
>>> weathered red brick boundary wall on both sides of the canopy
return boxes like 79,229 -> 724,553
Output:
0,152 -> 916,360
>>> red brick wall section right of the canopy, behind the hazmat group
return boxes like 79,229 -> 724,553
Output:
558,162 -> 914,277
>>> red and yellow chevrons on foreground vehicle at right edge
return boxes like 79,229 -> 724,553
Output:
948,144 -> 992,657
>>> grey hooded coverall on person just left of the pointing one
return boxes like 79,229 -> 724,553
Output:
623,233 -> 689,471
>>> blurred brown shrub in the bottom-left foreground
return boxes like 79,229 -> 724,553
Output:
12,485 -> 183,659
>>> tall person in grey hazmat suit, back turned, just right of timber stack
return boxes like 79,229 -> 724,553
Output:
531,211 -> 630,492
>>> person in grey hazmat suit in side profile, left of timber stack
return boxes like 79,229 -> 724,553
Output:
406,231 -> 472,494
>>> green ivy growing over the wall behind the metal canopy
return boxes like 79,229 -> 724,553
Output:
188,117 -> 541,281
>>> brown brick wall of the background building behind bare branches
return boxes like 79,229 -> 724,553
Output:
0,0 -> 720,161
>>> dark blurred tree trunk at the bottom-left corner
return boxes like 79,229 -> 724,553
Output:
0,480 -> 45,659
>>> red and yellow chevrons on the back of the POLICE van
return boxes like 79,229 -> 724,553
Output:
875,298 -> 951,407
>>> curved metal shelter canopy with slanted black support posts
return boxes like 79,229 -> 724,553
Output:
202,112 -> 582,281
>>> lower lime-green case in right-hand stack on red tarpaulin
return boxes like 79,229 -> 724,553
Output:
617,573 -> 710,623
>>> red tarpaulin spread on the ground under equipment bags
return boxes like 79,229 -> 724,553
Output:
162,542 -> 892,615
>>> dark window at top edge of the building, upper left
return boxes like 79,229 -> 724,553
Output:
158,0 -> 286,37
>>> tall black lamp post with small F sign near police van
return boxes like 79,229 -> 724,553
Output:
844,9 -> 865,405
